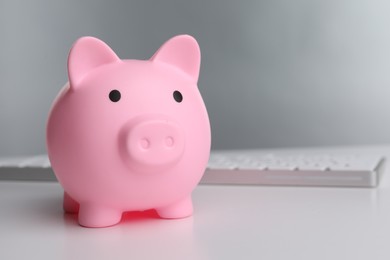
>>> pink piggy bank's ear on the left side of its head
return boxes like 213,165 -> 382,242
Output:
68,37 -> 120,88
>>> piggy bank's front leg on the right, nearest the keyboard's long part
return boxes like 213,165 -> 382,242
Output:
156,195 -> 193,218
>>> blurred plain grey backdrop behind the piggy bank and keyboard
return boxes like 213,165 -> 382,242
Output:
0,0 -> 390,155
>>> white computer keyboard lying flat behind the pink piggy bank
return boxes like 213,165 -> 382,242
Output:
0,150 -> 385,187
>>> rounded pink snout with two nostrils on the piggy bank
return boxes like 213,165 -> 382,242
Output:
122,116 -> 185,169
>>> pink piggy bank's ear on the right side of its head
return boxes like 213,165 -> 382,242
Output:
151,35 -> 200,82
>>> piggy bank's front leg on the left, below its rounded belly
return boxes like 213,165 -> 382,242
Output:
79,203 -> 122,227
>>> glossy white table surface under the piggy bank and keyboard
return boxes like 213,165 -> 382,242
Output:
0,146 -> 390,260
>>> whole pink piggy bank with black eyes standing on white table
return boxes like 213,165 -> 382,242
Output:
46,35 -> 211,227
